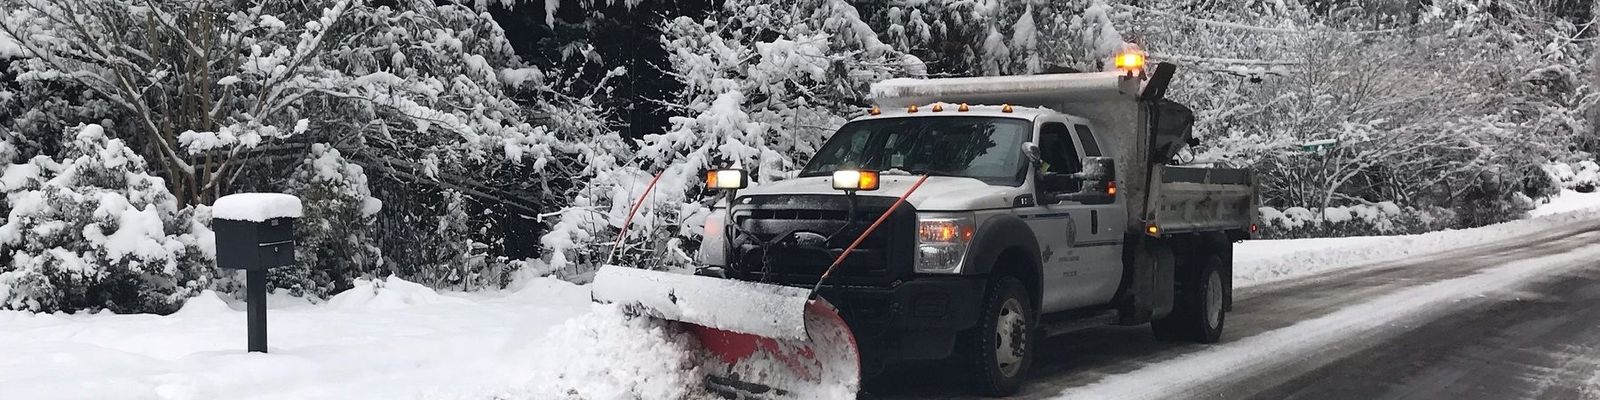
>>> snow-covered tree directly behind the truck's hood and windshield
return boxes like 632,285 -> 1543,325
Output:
541,0 -> 922,272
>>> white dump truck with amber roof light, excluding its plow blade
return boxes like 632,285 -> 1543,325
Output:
701,67 -> 1256,394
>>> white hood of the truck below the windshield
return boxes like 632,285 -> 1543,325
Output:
739,174 -> 1026,211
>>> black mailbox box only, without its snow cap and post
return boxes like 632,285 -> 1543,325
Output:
211,218 -> 294,269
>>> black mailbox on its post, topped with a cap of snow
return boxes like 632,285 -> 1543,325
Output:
211,194 -> 301,352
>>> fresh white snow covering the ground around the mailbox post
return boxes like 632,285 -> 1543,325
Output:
0,278 -> 696,398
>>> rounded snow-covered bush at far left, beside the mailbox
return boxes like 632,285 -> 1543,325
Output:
0,125 -> 216,314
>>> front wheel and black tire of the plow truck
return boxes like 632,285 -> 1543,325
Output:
962,277 -> 1038,397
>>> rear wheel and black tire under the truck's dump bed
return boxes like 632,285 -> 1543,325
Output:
1150,256 -> 1227,344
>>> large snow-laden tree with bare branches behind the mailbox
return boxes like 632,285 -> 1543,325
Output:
0,0 -> 563,296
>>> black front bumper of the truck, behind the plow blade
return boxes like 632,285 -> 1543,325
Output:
819,277 -> 987,363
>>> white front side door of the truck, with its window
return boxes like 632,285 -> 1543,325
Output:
1019,122 -> 1122,312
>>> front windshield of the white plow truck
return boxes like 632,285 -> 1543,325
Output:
800,117 -> 1032,184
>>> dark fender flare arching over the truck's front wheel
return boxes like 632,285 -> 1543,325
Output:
962,214 -> 1043,307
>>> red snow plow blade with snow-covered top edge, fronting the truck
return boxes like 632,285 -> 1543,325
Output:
590,266 -> 861,398
